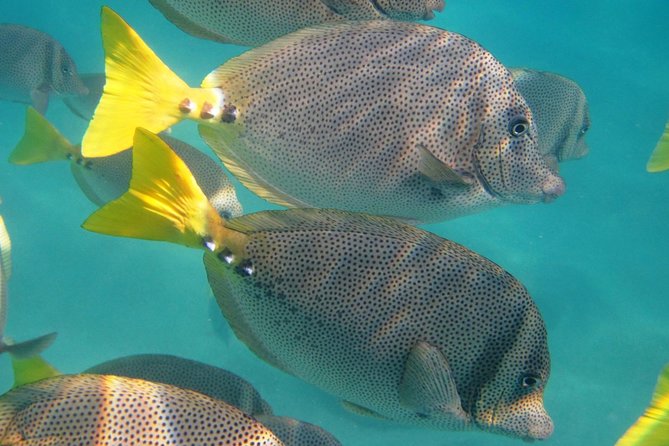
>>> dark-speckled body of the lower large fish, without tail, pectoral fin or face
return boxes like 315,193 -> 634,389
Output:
205,211 -> 549,428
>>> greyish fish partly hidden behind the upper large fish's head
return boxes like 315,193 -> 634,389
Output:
510,68 -> 590,171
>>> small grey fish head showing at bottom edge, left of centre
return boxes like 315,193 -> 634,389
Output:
256,415 -> 341,446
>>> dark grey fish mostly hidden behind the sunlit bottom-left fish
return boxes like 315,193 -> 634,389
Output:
84,355 -> 340,446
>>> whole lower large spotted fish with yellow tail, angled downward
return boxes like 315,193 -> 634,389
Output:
82,128 -> 553,440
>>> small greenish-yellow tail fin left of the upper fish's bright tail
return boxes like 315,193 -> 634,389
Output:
9,107 -> 78,164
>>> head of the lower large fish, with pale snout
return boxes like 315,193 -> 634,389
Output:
472,309 -> 553,441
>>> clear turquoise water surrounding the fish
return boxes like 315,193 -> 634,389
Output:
0,0 -> 669,446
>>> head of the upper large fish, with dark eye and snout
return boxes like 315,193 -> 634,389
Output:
473,83 -> 565,203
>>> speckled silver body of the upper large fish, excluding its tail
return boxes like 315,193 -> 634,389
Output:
209,21 -> 561,222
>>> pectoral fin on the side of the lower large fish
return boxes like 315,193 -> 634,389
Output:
399,342 -> 469,422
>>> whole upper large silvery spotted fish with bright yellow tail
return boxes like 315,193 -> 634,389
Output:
82,7 -> 565,223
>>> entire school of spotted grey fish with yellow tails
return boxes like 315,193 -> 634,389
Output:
0,0 -> 669,446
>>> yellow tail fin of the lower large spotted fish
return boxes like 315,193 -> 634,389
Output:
82,128 -> 220,248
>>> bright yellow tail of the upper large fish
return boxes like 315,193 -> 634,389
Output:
82,7 -> 222,157
